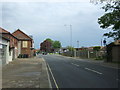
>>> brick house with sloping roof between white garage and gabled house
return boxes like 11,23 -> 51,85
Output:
0,27 -> 18,61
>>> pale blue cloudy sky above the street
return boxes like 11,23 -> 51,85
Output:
0,0 -> 112,48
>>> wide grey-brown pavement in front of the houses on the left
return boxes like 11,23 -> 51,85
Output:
2,57 -> 51,88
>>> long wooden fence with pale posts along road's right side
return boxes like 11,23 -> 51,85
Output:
63,50 -> 105,59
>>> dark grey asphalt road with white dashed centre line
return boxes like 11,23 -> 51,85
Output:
40,55 -> 119,88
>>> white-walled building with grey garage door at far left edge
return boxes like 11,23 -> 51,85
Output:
0,35 -> 10,66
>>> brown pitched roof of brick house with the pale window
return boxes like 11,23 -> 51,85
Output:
12,29 -> 32,40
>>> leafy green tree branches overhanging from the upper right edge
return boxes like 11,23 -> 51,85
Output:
98,0 -> 120,40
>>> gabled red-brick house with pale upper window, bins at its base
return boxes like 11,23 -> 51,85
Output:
12,29 -> 34,57
